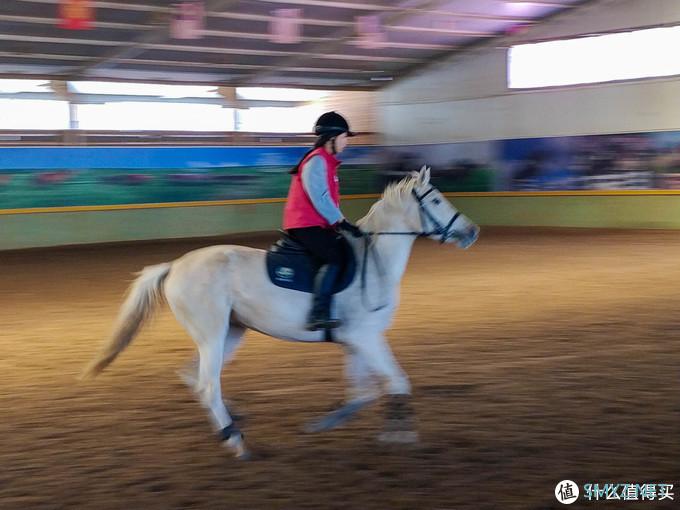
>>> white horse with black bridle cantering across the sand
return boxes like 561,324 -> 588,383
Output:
83,167 -> 479,458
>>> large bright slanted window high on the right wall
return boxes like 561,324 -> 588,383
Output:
508,26 -> 680,88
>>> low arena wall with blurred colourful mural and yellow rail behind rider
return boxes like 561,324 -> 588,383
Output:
6,135 -> 680,250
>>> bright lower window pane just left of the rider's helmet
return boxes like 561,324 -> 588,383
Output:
238,105 -> 323,133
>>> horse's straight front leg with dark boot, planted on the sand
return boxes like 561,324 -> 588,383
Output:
352,335 -> 418,443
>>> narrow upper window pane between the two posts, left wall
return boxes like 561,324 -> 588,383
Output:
69,81 -> 220,99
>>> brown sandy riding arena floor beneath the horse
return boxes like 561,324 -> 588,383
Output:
0,229 -> 680,510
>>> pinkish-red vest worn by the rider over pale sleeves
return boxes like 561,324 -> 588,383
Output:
283,147 -> 340,230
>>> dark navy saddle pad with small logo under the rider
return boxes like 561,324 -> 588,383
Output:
267,232 -> 356,294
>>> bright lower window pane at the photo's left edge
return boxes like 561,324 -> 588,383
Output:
0,99 -> 69,129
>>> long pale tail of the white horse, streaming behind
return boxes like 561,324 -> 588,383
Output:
80,262 -> 172,380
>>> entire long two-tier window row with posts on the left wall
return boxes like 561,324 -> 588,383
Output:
0,80 -> 330,134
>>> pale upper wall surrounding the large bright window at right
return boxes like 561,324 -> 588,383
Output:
378,0 -> 680,143
